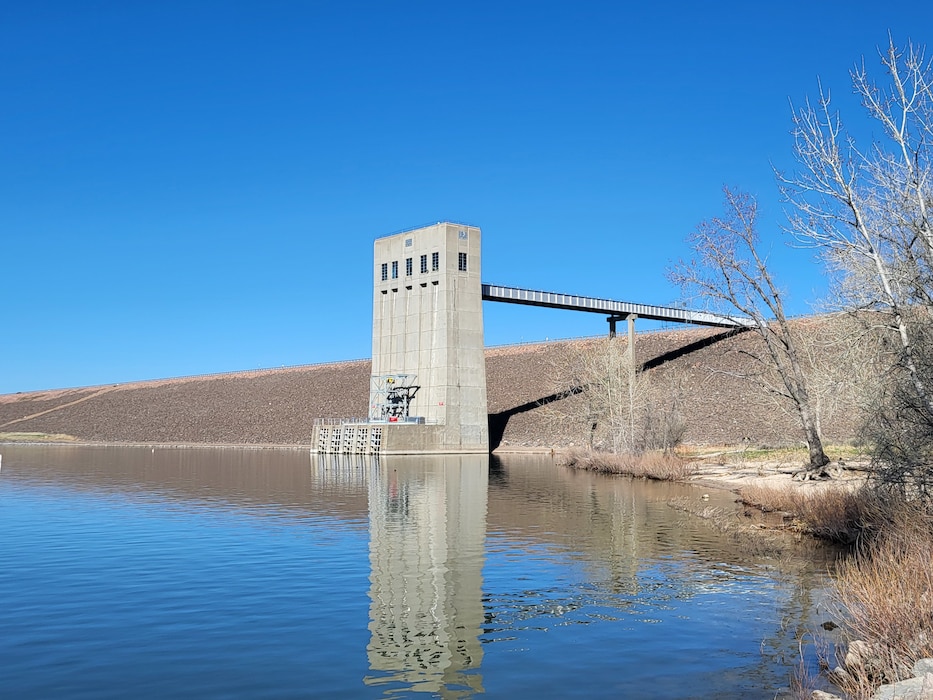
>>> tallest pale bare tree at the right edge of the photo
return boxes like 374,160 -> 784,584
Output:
778,40 -> 933,491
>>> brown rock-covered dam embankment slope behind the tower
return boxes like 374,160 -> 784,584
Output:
0,329 -> 859,449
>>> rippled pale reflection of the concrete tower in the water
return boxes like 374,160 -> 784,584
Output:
364,455 -> 489,698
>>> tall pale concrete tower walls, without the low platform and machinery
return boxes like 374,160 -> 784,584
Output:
372,223 -> 489,452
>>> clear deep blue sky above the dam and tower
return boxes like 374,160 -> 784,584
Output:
0,0 -> 933,393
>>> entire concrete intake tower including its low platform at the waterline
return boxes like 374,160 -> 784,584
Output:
312,222 -> 489,454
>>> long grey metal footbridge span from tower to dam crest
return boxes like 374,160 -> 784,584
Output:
483,284 -> 751,328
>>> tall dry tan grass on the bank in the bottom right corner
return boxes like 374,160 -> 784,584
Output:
741,485 -> 933,700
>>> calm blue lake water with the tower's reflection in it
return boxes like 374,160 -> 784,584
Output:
0,445 -> 826,698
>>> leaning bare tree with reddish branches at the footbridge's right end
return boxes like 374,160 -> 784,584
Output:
668,188 -> 829,471
